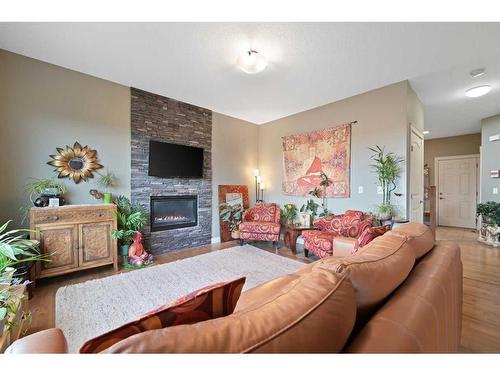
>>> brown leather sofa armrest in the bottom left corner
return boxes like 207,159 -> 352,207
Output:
5,328 -> 68,354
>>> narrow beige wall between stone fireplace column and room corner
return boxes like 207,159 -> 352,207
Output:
212,112 -> 259,238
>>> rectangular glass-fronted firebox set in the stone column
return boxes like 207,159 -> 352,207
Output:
150,195 -> 198,232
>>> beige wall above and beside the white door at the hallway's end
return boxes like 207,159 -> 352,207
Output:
424,133 -> 481,186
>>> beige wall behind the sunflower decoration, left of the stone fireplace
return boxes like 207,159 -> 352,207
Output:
0,50 -> 130,228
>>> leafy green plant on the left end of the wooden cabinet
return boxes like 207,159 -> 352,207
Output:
21,177 -> 68,223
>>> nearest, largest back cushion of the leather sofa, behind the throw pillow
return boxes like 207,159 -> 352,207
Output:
105,269 -> 356,353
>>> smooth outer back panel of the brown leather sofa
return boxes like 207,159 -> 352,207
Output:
347,243 -> 463,353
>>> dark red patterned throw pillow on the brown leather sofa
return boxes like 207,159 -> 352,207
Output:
80,277 -> 245,353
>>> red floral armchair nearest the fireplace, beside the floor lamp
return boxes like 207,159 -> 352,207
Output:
239,203 -> 281,245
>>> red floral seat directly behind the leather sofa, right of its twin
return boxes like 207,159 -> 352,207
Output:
302,210 -> 373,258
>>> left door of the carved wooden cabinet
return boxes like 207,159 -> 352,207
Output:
37,225 -> 78,276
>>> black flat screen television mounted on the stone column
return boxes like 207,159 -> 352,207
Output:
148,141 -> 203,178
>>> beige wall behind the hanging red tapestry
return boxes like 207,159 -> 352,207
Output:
259,81 -> 412,214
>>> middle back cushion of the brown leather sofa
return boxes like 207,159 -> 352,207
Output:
314,232 -> 415,321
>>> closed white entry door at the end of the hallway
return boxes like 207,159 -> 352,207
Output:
436,156 -> 478,228
